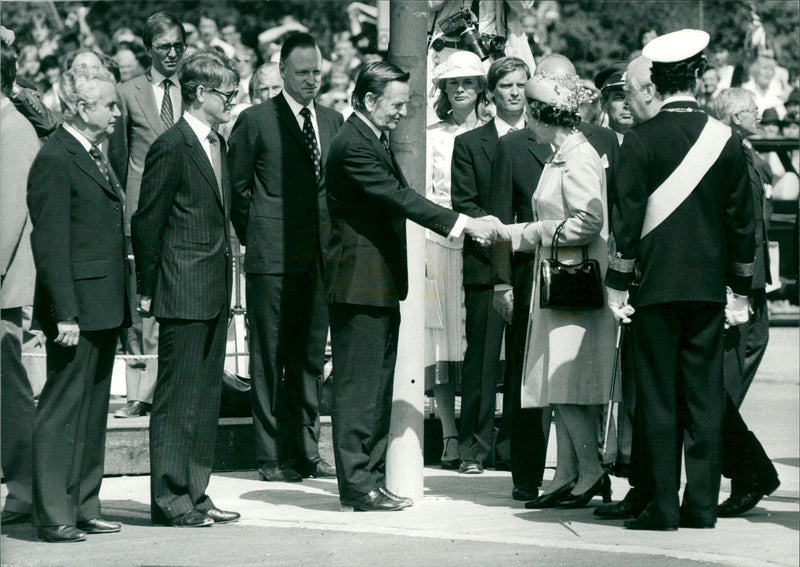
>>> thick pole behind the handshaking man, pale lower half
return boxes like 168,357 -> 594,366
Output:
378,0 -> 428,500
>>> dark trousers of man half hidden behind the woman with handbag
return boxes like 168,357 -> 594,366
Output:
506,300 -> 550,488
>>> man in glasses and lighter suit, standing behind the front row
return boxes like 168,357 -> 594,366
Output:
108,12 -> 186,417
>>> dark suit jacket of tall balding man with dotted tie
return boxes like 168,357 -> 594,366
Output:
228,94 -> 342,274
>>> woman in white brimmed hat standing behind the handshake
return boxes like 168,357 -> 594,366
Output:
425,51 -> 488,469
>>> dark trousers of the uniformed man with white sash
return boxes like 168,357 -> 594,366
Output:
633,302 -> 725,526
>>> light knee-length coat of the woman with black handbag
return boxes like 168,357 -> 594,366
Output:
512,132 -> 616,408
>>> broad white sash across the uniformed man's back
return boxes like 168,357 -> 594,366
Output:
641,117 -> 731,238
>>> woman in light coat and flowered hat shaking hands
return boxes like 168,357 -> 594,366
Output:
506,77 -> 616,508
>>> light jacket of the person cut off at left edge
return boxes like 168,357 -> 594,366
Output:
0,98 -> 39,309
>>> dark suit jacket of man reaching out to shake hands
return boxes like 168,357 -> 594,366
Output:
325,114 -> 458,307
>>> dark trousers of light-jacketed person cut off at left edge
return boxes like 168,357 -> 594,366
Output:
0,307 -> 36,514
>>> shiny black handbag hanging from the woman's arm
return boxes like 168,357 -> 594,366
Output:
539,221 -> 603,310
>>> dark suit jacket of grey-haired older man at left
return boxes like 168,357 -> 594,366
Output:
27,127 -> 131,334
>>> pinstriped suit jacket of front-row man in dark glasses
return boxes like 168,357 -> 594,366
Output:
131,118 -> 232,320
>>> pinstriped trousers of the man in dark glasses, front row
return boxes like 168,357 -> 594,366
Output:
150,308 -> 227,523
